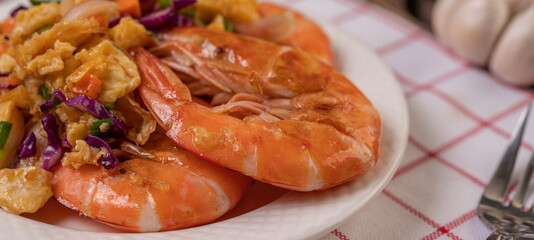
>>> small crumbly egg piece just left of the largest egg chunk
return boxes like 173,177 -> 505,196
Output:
28,40 -> 76,75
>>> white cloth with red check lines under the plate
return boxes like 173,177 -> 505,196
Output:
272,0 -> 534,240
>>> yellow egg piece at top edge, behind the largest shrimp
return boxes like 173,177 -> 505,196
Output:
195,0 -> 260,23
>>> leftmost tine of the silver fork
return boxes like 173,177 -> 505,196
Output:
483,102 -> 532,203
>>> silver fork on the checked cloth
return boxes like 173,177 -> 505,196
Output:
477,103 -> 534,240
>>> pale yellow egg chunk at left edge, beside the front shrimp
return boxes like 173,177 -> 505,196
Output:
0,167 -> 53,214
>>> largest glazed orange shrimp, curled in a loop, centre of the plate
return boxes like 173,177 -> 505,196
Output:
130,28 -> 381,191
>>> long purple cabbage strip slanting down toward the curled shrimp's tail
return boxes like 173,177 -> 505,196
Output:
40,91 -> 128,136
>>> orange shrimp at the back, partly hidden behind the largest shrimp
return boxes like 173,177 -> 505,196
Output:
236,2 -> 334,64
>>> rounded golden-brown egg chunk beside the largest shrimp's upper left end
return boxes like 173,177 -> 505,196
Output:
109,17 -> 152,50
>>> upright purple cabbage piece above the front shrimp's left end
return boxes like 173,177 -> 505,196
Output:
41,113 -> 63,171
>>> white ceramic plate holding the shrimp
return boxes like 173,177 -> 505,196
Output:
0,1 -> 408,240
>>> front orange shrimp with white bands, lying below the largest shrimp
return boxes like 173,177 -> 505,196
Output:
52,135 -> 252,232
